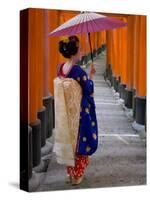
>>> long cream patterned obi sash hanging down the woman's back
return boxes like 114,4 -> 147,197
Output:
53,77 -> 82,166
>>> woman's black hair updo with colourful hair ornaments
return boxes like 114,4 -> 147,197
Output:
59,35 -> 79,58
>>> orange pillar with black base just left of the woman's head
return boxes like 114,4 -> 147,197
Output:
43,10 -> 59,138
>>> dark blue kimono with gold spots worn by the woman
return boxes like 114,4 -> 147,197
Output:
58,65 -> 98,155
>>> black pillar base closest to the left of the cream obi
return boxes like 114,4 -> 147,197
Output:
43,96 -> 55,138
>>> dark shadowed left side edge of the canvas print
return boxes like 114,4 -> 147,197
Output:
20,9 -> 33,191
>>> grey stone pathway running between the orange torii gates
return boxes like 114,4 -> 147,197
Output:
36,52 -> 146,191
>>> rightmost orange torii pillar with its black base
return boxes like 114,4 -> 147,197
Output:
134,16 -> 146,129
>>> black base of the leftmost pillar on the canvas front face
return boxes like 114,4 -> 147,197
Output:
30,119 -> 41,167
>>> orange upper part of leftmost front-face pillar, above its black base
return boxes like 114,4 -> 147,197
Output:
28,9 -> 44,123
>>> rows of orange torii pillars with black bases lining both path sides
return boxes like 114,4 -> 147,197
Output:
20,8 -> 146,190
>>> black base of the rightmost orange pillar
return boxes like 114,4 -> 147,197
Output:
135,96 -> 146,125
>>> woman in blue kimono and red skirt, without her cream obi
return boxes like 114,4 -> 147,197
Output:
57,36 -> 98,185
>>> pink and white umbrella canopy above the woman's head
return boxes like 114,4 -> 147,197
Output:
49,12 -> 127,36
